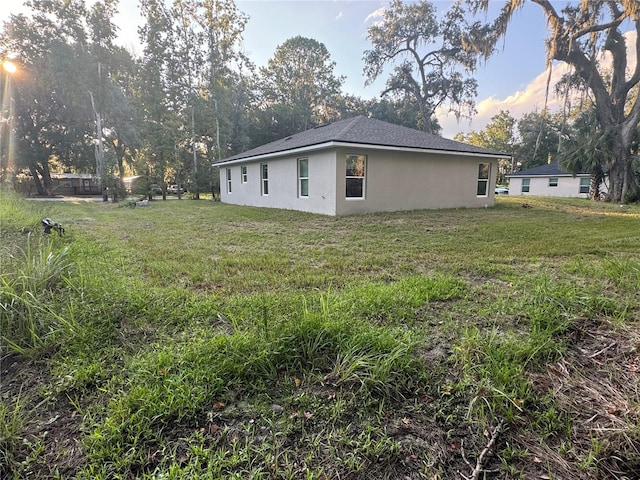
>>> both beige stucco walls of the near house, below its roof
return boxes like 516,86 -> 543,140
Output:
220,148 -> 497,215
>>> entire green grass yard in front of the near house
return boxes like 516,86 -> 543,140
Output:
0,192 -> 640,480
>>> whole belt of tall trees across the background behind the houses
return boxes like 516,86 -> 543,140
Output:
0,0 -> 640,201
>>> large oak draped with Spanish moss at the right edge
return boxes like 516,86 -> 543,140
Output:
467,0 -> 640,202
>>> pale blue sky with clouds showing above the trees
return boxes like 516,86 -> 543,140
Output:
0,0 -> 636,138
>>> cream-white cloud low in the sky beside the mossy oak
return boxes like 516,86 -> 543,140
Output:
436,31 -> 637,138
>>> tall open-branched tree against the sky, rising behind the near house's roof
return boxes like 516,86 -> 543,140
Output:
364,0 -> 477,132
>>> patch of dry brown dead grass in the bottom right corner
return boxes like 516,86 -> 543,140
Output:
522,322 -> 640,479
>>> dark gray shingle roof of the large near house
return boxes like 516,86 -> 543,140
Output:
218,116 -> 508,163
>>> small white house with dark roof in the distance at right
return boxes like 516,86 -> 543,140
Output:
506,163 -> 608,198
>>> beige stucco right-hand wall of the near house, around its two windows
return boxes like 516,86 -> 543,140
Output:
336,149 -> 497,215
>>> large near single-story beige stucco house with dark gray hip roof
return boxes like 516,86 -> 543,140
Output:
216,116 -> 508,215
